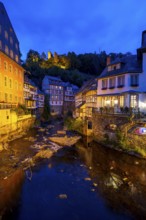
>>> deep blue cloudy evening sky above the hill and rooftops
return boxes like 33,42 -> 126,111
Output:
2,0 -> 146,59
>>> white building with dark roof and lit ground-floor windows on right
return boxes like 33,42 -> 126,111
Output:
97,31 -> 146,113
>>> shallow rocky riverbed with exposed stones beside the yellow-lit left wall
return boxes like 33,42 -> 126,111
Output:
0,123 -> 81,179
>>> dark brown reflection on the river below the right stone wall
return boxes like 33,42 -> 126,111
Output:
77,141 -> 146,219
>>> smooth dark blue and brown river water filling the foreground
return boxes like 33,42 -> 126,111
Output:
2,131 -> 146,220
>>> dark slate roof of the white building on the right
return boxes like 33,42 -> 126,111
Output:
98,55 -> 142,79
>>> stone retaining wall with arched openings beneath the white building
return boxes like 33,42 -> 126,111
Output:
84,114 -> 146,157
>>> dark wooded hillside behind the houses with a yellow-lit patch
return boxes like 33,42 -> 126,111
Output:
23,50 -> 132,89
